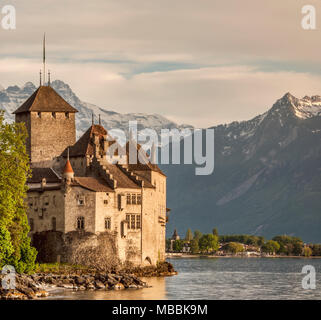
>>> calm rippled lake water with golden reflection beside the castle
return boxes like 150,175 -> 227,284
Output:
47,258 -> 321,300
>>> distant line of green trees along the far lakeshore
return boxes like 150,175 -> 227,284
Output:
166,228 -> 321,257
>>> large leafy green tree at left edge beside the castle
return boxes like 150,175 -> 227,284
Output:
0,112 -> 37,273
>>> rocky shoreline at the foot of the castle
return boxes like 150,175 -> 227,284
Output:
0,262 -> 177,300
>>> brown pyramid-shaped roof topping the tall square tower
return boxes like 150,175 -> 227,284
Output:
13,86 -> 78,114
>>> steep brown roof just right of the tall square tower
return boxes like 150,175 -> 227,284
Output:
63,124 -> 107,157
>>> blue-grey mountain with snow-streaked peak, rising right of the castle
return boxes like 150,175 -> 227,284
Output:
161,93 -> 321,242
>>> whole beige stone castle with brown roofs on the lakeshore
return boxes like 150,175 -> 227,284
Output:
14,85 -> 168,265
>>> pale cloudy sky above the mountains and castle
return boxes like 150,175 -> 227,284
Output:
0,0 -> 321,127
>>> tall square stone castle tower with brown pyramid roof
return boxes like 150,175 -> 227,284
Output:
13,86 -> 77,167
